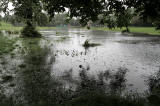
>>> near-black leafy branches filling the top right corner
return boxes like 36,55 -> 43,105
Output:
125,0 -> 160,29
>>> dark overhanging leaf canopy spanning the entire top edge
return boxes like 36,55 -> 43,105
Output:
0,0 -> 160,36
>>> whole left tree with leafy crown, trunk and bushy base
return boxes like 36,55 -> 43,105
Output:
12,0 -> 42,37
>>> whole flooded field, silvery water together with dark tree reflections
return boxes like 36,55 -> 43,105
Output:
0,29 -> 160,106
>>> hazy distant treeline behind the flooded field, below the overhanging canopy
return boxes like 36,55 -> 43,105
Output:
0,14 -> 153,27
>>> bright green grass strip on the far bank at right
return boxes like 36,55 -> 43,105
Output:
92,27 -> 160,35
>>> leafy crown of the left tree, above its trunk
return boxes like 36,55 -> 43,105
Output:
12,0 -> 42,22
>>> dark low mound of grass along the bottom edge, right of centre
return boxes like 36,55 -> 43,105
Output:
68,92 -> 144,106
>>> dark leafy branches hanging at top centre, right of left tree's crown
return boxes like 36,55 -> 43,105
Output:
44,0 -> 104,24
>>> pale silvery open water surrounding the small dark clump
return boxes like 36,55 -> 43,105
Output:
42,29 -> 160,92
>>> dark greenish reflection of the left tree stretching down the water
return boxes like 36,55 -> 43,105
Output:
14,40 -> 69,106
